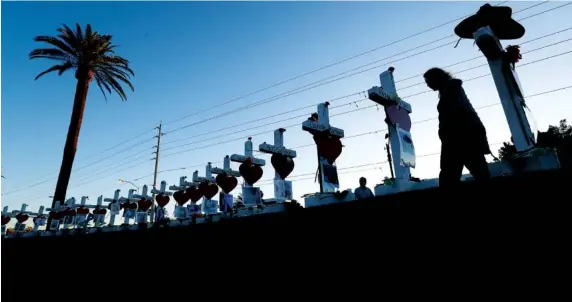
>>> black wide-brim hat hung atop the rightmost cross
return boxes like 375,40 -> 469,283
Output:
455,3 -> 525,40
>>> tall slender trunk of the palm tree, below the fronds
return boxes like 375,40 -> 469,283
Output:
47,72 -> 90,227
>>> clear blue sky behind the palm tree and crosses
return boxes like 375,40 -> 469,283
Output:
1,2 -> 572,215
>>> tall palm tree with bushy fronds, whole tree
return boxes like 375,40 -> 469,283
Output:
29,24 -> 135,212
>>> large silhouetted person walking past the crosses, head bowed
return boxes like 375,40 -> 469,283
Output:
423,68 -> 491,187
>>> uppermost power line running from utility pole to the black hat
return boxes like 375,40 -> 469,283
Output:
161,1 -> 510,124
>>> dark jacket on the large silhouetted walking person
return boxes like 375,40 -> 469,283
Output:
437,79 -> 491,154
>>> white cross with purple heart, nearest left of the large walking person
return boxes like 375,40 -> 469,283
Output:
367,67 -> 412,182
